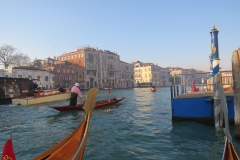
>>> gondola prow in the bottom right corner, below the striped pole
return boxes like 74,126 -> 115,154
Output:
218,85 -> 239,160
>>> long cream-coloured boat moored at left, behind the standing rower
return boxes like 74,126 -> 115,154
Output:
12,90 -> 70,106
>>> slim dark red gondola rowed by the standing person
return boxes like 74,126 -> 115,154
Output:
48,97 -> 125,111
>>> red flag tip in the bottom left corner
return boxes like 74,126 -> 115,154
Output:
1,139 -> 16,160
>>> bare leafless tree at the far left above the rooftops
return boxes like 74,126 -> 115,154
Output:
0,45 -> 31,69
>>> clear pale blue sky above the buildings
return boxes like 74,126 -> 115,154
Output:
0,0 -> 240,71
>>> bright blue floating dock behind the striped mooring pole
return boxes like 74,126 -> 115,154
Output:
171,91 -> 234,124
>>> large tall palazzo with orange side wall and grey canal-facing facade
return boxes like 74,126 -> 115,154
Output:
58,47 -> 133,89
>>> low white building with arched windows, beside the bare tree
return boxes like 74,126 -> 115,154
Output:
12,66 -> 54,89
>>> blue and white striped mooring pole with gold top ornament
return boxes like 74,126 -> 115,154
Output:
210,24 -> 223,127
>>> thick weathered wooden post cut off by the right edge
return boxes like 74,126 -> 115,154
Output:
232,50 -> 240,139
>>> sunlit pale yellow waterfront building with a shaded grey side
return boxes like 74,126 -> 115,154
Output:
132,61 -> 170,87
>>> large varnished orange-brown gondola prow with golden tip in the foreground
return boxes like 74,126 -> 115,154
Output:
33,88 -> 99,160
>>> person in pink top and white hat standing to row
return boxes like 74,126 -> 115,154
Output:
69,83 -> 82,106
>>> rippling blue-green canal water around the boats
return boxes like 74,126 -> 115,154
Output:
0,87 -> 240,160
